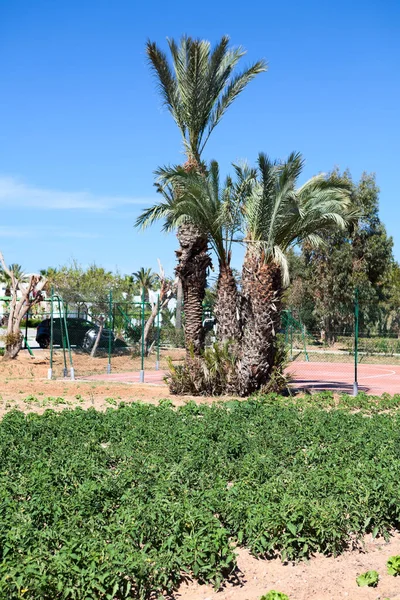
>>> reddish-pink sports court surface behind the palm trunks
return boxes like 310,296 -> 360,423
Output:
81,361 -> 400,395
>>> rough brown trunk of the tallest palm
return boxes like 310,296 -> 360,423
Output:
176,223 -> 211,355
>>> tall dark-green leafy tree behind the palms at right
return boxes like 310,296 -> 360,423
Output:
288,171 -> 393,343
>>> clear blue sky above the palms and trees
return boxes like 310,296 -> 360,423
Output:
0,0 -> 400,273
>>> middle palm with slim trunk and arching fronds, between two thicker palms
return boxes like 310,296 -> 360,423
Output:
136,161 -> 255,344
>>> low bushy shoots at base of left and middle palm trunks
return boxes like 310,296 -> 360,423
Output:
165,342 -> 237,396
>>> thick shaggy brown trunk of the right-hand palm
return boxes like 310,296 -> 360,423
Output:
238,250 -> 282,396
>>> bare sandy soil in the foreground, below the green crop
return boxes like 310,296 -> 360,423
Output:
175,533 -> 400,600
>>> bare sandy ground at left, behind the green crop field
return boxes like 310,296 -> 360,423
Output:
0,350 -> 219,418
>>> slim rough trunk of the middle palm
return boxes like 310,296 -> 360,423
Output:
215,264 -> 241,344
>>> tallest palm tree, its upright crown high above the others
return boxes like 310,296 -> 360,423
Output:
147,36 -> 266,353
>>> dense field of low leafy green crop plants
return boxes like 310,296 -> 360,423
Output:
0,395 -> 400,600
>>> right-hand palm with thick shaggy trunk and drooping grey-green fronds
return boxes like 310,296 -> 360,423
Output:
239,153 -> 357,395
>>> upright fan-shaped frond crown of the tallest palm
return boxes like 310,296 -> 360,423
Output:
146,36 -> 267,163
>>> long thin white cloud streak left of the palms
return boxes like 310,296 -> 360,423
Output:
0,175 -> 154,212
